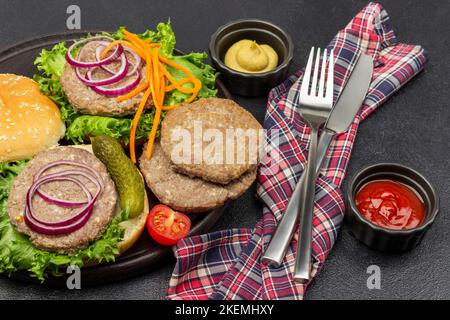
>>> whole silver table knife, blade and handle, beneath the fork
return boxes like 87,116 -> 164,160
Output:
261,54 -> 373,267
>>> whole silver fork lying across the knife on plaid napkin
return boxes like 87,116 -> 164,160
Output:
294,47 -> 334,281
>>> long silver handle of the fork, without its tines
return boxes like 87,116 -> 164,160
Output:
294,125 -> 318,281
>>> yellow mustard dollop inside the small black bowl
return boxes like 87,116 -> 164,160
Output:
224,39 -> 278,73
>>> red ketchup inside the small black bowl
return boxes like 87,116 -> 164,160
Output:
355,180 -> 425,230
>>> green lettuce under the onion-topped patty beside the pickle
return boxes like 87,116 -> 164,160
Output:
0,160 -> 128,281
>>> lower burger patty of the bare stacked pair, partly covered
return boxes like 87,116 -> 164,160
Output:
139,142 -> 256,212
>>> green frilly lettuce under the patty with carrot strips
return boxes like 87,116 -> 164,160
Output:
34,21 -> 217,145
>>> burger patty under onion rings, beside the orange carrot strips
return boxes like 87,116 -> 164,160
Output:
60,45 -> 152,116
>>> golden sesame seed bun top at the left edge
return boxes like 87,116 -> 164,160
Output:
0,74 -> 65,162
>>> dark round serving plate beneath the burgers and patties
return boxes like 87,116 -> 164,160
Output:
0,31 -> 232,287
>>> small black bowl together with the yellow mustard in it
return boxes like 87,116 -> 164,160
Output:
209,19 -> 294,97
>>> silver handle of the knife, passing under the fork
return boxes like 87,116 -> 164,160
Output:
261,130 -> 334,267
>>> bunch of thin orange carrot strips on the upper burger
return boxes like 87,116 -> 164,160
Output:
119,30 -> 202,163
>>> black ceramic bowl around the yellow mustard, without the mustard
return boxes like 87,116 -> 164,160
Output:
209,19 -> 294,97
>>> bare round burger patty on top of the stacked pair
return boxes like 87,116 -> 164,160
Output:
161,98 -> 262,185
